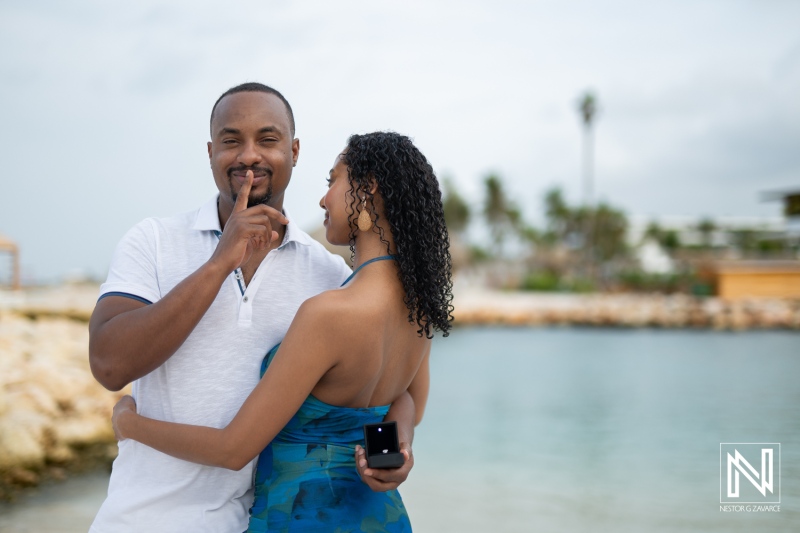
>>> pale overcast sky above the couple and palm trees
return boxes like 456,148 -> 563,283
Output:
0,0 -> 800,282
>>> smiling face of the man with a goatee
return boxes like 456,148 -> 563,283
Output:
208,92 -> 300,212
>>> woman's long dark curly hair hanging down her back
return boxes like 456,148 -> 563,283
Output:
342,131 -> 453,338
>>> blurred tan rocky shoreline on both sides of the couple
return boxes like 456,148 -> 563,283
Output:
0,283 -> 800,501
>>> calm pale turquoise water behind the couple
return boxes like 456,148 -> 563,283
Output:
0,328 -> 800,533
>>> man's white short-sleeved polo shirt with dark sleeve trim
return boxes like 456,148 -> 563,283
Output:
90,196 -> 350,533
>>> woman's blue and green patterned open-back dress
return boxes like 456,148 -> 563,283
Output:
247,345 -> 411,533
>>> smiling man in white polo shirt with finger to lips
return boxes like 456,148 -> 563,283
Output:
89,83 -> 415,533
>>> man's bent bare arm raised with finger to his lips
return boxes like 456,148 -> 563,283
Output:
89,172 -> 288,390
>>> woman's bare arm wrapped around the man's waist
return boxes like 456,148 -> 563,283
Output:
114,299 -> 344,470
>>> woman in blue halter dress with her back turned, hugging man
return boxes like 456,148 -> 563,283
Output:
114,132 -> 452,532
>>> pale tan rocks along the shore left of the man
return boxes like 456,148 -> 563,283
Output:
0,287 -> 123,500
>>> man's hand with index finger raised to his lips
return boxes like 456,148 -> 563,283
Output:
209,170 -> 289,272
